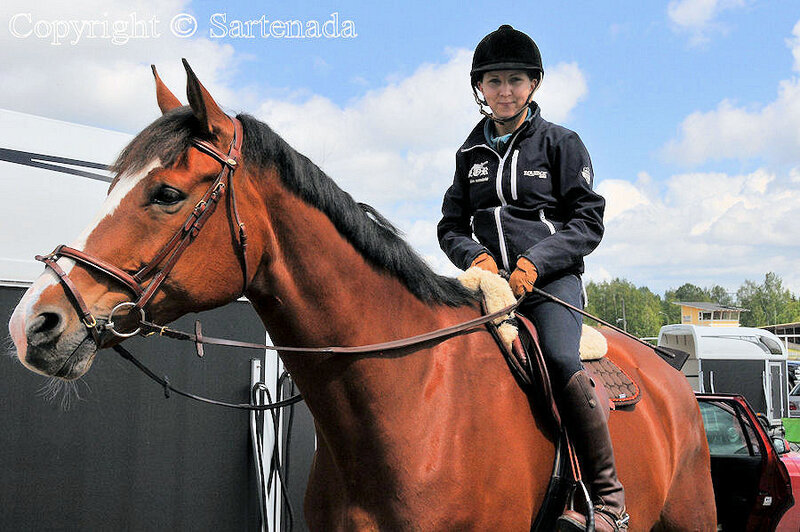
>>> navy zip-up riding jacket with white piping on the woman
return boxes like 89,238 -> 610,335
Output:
438,102 -> 605,280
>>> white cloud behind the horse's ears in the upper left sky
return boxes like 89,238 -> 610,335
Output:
0,0 -> 237,131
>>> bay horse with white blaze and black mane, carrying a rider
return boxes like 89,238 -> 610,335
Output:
9,61 -> 716,531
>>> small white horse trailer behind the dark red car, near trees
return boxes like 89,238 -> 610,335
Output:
658,324 -> 789,423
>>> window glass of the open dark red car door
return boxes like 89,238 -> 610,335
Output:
700,401 -> 760,456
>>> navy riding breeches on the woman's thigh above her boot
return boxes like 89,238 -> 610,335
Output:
517,274 -> 583,395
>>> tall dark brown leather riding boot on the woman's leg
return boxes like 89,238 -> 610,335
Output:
558,370 -> 628,532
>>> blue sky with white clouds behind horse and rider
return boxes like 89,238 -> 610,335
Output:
0,0 -> 800,294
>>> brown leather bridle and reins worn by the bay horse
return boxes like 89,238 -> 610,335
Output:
35,117 -> 524,410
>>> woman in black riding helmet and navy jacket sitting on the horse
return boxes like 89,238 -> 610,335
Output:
438,25 -> 628,531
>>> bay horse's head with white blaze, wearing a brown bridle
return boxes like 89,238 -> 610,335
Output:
9,60 -> 257,380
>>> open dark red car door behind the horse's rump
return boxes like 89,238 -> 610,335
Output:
696,393 -> 794,532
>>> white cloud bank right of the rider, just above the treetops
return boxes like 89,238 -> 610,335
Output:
588,167 -> 800,291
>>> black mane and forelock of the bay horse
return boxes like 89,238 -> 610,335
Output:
113,107 -> 475,306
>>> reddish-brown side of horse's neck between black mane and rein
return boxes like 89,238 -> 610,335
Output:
248,182 -> 437,346
